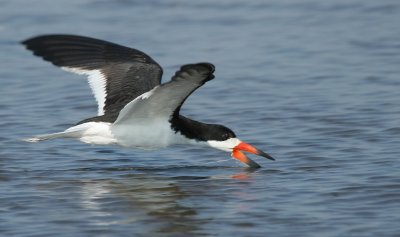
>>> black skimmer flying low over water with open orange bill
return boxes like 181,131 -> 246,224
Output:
22,35 -> 274,168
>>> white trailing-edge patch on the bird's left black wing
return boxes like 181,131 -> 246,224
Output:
61,67 -> 107,116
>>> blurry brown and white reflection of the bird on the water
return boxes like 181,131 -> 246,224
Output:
77,170 -> 253,236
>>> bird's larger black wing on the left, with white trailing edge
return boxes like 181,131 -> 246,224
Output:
22,35 -> 162,122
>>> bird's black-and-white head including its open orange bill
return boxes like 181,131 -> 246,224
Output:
207,125 -> 275,168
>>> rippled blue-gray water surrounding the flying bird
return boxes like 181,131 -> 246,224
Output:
0,0 -> 400,236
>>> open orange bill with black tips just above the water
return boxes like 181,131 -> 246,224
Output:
232,142 -> 275,168
